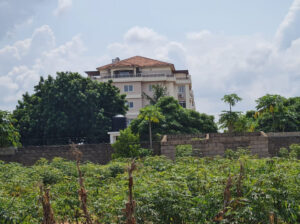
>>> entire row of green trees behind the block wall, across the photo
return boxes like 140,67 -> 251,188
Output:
0,72 -> 300,147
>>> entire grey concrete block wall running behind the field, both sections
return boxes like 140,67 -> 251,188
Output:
0,132 -> 300,165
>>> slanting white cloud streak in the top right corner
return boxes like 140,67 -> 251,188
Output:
275,0 -> 300,49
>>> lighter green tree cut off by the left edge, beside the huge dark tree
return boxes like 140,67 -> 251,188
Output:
0,110 -> 21,148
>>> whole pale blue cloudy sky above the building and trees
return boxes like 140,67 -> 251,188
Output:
0,0 -> 300,115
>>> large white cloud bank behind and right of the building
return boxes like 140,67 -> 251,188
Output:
108,21 -> 300,115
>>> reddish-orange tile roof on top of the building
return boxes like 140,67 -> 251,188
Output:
97,56 -> 175,70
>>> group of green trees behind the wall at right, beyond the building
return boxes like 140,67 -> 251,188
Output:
219,94 -> 300,132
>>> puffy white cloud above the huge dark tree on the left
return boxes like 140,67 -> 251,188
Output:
0,25 -> 86,110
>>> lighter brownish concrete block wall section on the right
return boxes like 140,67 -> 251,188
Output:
161,132 -> 300,159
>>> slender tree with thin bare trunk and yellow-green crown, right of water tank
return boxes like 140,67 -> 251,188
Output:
138,105 -> 164,149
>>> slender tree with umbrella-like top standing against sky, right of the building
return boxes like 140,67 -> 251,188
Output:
219,93 -> 242,133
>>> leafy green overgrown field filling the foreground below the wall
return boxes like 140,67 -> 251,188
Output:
0,156 -> 300,223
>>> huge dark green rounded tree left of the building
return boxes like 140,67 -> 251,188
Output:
13,72 -> 127,145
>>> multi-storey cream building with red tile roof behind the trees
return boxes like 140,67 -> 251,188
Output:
86,56 -> 195,122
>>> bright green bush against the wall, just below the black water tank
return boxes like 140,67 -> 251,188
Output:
112,128 -> 151,158
